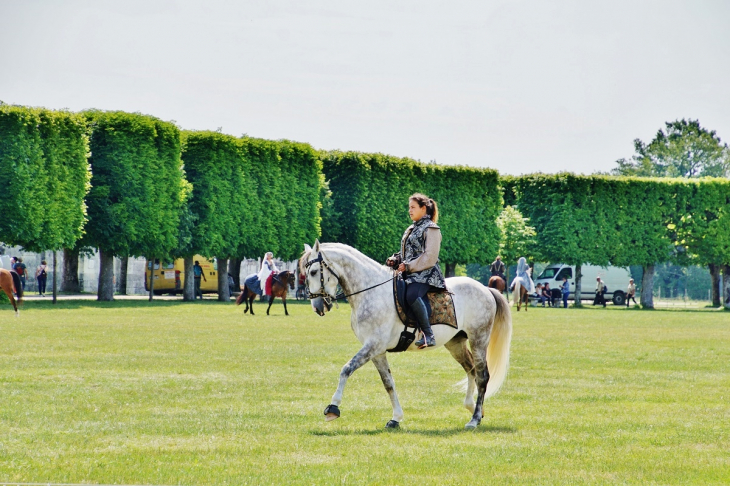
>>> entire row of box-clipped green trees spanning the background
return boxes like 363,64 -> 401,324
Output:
0,104 -> 730,307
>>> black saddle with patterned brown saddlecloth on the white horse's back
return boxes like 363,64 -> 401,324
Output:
388,275 -> 459,353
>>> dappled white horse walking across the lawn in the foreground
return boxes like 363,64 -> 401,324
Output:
299,241 -> 512,429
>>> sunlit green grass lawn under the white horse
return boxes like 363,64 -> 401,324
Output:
0,301 -> 730,485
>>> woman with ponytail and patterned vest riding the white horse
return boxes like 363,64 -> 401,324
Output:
387,194 -> 446,349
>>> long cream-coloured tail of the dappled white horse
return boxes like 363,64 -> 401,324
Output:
484,289 -> 512,398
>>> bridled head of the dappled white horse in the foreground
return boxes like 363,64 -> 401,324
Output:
299,240 -> 339,316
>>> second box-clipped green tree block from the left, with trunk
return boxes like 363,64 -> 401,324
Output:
84,111 -> 188,300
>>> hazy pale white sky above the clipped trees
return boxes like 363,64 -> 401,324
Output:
0,0 -> 730,174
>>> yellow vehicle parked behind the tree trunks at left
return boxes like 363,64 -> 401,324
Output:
144,255 -> 220,295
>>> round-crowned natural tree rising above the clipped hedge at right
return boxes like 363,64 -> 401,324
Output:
613,119 -> 730,177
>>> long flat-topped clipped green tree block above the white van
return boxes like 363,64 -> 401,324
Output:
505,174 -> 730,307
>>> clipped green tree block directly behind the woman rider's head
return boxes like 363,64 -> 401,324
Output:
322,151 -> 502,265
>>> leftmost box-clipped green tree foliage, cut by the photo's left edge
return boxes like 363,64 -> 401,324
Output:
0,104 -> 90,252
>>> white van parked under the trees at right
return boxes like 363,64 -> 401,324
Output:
534,263 -> 631,305
